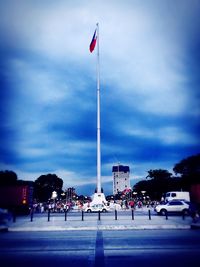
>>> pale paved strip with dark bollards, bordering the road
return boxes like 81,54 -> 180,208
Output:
0,210 -> 200,232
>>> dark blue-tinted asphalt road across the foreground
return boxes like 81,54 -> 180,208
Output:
0,230 -> 200,267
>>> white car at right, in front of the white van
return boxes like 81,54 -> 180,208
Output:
154,200 -> 189,215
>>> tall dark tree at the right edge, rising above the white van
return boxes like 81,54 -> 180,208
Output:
173,154 -> 200,189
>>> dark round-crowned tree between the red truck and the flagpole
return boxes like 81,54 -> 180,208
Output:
35,174 -> 63,202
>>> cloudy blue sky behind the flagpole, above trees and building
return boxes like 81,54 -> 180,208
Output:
0,0 -> 200,197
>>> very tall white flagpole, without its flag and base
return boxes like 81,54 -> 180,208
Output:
97,23 -> 101,193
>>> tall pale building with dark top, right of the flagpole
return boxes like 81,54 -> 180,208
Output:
112,165 -> 130,195
